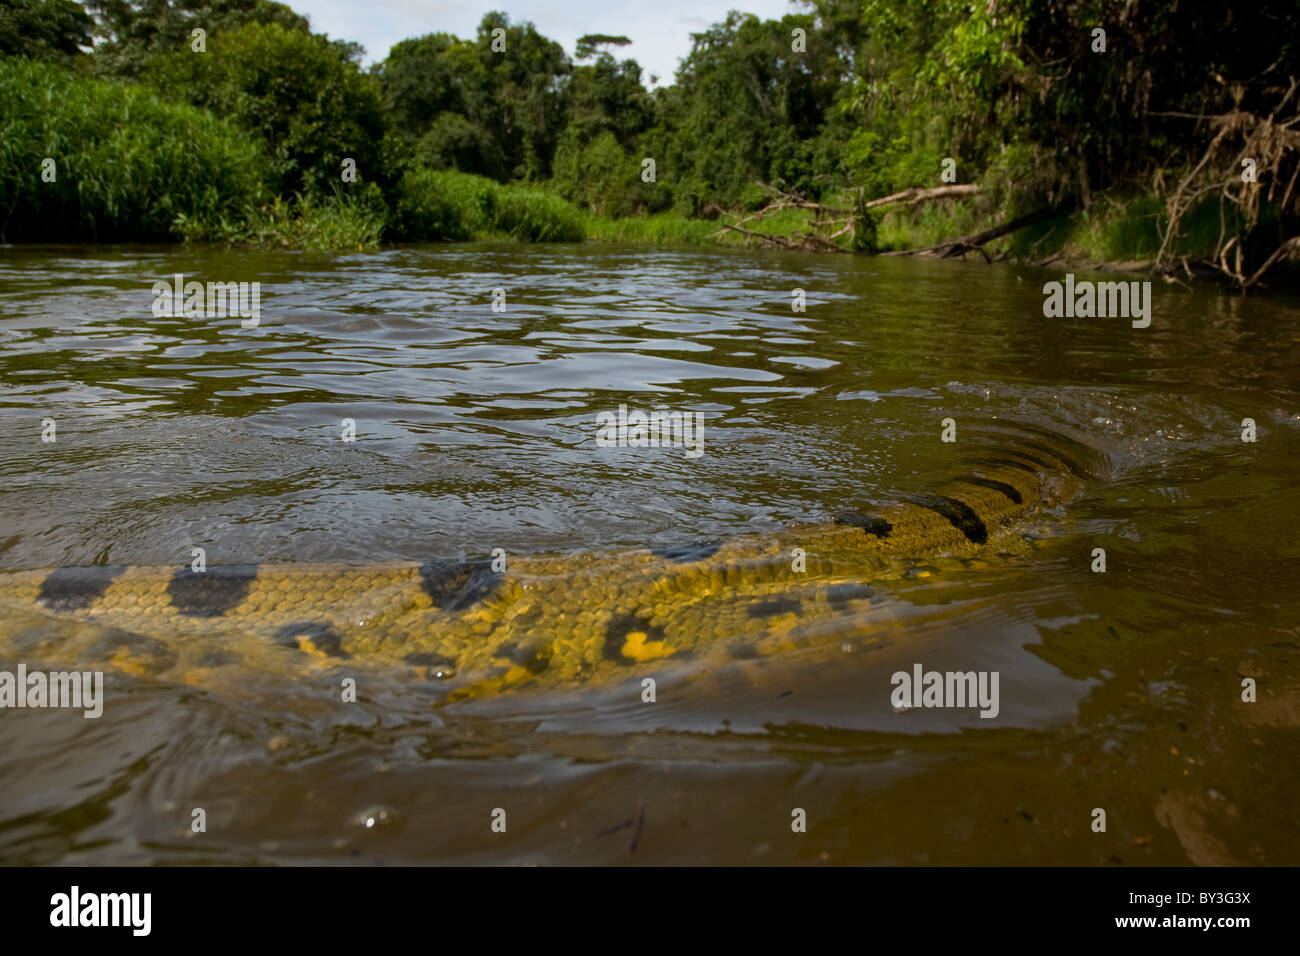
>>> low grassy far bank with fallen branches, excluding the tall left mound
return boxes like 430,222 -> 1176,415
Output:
172,192 -> 1300,293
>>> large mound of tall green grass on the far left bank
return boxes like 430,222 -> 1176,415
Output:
0,59 -> 268,242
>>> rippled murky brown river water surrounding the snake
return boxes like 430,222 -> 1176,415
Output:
0,245 -> 1300,865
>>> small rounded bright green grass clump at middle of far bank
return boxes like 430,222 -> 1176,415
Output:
393,169 -> 586,242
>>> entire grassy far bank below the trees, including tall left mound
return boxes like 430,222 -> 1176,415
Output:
0,52 -> 1300,290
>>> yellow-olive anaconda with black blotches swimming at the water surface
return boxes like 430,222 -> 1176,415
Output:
0,428 -> 1095,700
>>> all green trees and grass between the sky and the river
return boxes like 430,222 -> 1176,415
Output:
0,0 -> 1300,290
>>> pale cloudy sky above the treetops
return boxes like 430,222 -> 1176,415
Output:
282,0 -> 809,85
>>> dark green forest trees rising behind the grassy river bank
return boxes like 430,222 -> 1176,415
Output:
0,0 -> 1300,271
